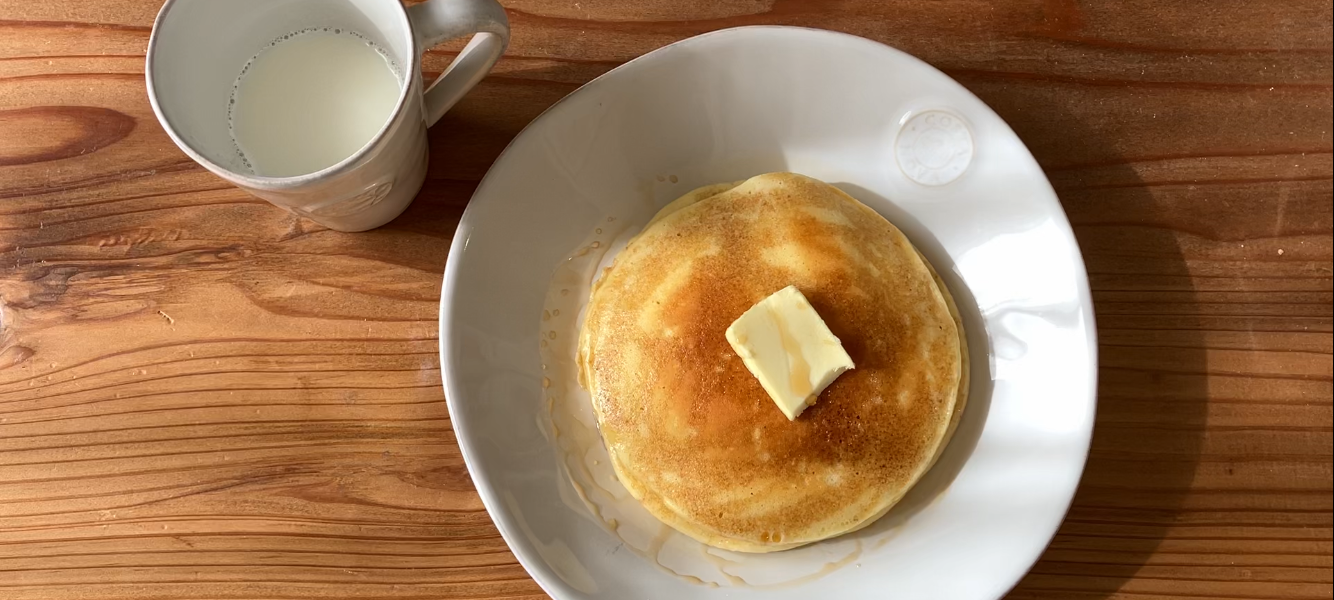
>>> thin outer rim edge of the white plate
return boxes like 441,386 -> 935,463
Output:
438,25 -> 1099,600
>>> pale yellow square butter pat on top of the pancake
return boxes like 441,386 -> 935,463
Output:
727,285 -> 854,421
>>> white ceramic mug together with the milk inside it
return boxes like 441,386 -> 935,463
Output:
145,0 -> 510,231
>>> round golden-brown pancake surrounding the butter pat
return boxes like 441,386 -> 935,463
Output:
579,173 -> 967,552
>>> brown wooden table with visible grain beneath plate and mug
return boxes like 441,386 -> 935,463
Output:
0,0 -> 1334,600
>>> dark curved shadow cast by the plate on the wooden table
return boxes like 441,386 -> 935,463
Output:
964,86 -> 1209,600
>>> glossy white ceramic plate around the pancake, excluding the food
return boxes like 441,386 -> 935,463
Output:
440,27 -> 1095,600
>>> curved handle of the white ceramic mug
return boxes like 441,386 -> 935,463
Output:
408,0 -> 510,127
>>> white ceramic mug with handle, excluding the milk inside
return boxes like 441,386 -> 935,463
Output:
145,0 -> 510,231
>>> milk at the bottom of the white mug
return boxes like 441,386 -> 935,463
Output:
228,28 -> 402,177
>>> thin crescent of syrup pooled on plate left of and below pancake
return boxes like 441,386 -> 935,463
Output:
539,217 -> 894,589
